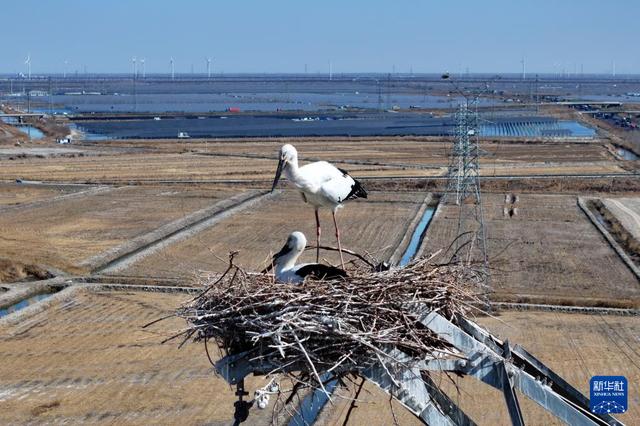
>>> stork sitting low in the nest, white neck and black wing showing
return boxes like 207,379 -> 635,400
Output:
273,231 -> 347,284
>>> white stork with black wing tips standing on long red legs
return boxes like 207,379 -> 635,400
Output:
271,144 -> 367,268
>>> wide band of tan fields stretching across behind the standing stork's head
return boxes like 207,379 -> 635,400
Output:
0,138 -> 625,184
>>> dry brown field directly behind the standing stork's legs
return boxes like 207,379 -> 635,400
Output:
116,191 -> 425,277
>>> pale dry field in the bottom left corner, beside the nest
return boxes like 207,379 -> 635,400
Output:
0,291 -> 284,425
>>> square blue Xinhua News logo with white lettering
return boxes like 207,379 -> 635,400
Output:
589,376 -> 629,414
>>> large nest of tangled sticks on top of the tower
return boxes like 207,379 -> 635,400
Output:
178,253 -> 479,387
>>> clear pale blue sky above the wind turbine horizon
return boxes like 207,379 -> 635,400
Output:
0,0 -> 640,74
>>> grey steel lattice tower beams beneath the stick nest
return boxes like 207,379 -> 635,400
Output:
216,311 -> 623,426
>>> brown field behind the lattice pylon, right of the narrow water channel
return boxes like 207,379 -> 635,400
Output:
425,194 -> 640,307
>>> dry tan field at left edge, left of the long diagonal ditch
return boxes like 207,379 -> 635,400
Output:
0,186 -> 235,273
